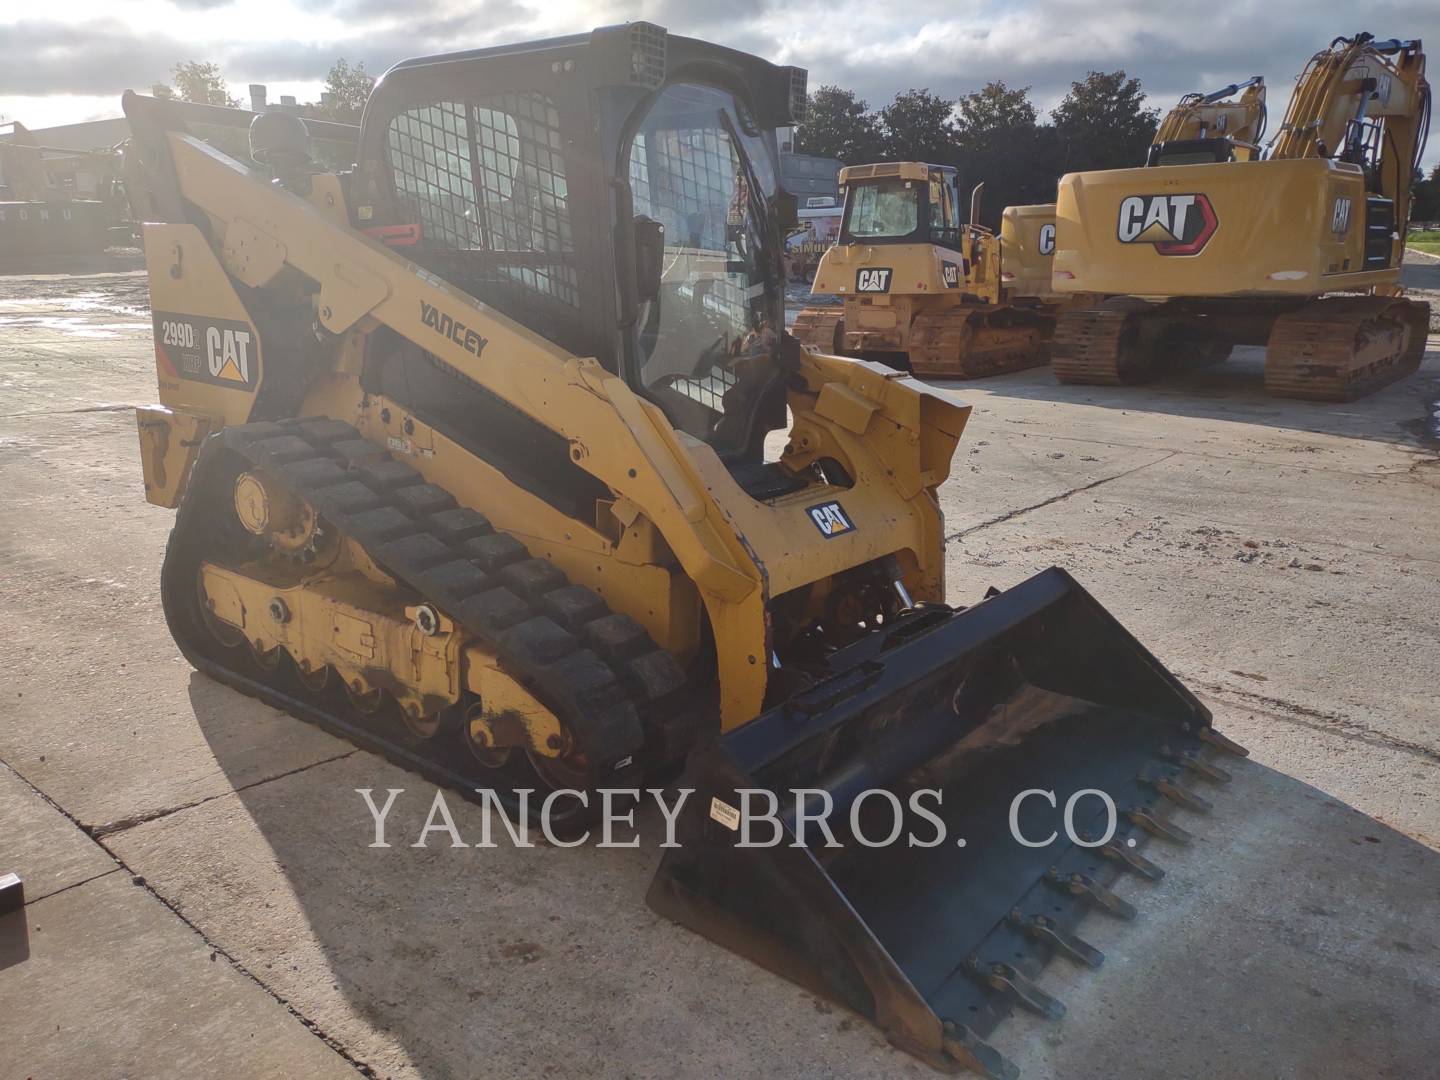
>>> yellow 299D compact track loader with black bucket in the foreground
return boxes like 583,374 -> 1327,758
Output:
124,23 -> 1240,1077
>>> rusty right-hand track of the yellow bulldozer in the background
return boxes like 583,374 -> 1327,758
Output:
910,305 -> 1053,379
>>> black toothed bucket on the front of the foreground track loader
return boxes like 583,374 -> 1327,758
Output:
648,569 -> 1244,1077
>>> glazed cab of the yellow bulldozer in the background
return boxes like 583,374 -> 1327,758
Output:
840,161 -> 962,251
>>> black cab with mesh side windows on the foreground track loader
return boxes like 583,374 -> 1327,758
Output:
344,23 -> 805,458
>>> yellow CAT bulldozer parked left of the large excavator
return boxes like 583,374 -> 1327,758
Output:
795,161 -> 1058,379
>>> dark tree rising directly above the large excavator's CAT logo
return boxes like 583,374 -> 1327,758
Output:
1050,71 -> 1161,173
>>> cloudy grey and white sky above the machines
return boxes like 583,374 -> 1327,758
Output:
0,0 -> 1440,163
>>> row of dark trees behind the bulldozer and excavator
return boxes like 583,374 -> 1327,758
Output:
795,71 -> 1161,228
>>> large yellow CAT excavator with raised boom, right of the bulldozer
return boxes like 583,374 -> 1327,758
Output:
1053,33 -> 1430,402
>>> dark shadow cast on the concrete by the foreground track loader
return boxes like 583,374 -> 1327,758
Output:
185,675 -> 1440,1080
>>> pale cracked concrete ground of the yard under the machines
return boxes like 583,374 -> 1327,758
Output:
8,264 -> 1440,1080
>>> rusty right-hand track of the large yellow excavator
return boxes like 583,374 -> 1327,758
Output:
1264,297 -> 1430,402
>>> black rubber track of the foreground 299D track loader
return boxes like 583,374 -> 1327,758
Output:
161,418 -> 698,834
